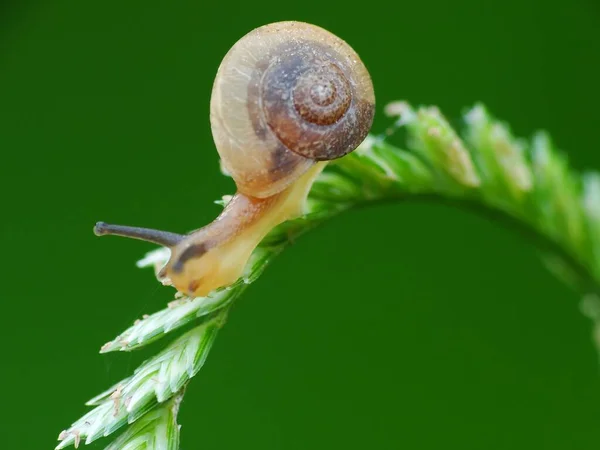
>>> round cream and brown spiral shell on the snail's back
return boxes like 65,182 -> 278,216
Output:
210,22 -> 375,198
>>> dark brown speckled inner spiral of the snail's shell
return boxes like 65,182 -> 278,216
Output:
260,40 -> 374,161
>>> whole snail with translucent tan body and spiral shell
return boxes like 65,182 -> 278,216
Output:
94,22 -> 375,297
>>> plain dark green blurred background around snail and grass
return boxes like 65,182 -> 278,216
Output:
0,0 -> 600,450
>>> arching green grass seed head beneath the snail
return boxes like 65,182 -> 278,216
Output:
57,102 -> 600,450
